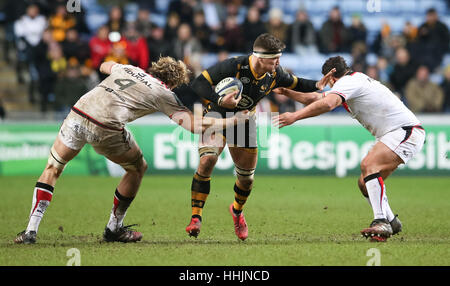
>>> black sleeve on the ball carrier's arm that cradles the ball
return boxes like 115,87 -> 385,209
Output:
191,58 -> 237,102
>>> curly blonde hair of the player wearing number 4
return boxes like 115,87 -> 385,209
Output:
148,57 -> 190,88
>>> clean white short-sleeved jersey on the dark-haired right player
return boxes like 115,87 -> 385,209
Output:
325,72 -> 420,138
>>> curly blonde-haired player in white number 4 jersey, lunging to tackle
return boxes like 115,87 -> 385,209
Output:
14,57 -> 245,244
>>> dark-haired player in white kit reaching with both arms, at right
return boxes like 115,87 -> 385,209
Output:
273,56 -> 425,242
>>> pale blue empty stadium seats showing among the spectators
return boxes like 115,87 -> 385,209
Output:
76,0 -> 450,88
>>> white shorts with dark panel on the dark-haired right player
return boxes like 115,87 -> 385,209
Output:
378,125 -> 425,164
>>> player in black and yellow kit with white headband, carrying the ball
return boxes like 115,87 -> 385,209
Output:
186,34 -> 331,240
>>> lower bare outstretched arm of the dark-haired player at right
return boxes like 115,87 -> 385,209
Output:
272,93 -> 342,128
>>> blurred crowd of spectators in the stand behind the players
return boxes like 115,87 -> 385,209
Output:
0,0 -> 450,116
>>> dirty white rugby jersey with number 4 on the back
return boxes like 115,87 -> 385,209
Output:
73,64 -> 188,129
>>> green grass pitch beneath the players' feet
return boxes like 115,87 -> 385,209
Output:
0,175 -> 450,266
